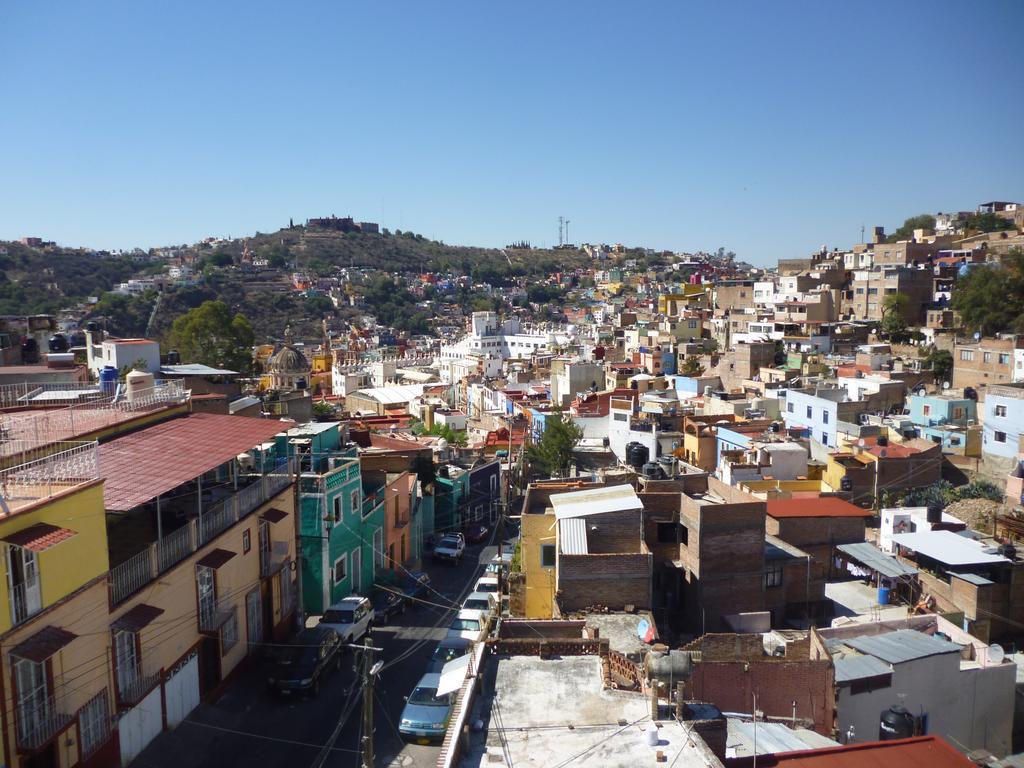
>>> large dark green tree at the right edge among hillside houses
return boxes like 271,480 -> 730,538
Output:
950,248 -> 1024,336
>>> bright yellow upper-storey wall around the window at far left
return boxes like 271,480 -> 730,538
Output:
0,481 -> 109,633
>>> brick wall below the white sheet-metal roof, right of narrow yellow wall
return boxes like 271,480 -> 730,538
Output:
557,553 -> 651,612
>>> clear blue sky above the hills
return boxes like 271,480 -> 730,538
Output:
0,0 -> 1024,264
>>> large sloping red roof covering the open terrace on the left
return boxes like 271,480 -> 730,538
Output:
99,414 -> 287,512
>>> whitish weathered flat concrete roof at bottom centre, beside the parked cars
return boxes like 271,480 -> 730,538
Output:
460,656 -> 718,768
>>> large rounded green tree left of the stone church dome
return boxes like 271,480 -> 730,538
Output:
169,301 -> 256,373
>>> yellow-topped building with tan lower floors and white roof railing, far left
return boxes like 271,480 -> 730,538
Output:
0,442 -> 117,766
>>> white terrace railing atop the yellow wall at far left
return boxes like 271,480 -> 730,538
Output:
0,440 -> 99,514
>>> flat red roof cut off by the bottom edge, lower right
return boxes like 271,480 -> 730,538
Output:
732,736 -> 974,768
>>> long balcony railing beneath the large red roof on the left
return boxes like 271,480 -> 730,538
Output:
109,460 -> 295,605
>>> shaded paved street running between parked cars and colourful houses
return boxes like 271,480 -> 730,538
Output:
132,546 -> 495,768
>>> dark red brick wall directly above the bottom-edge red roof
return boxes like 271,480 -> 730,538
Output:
686,658 -> 836,735
